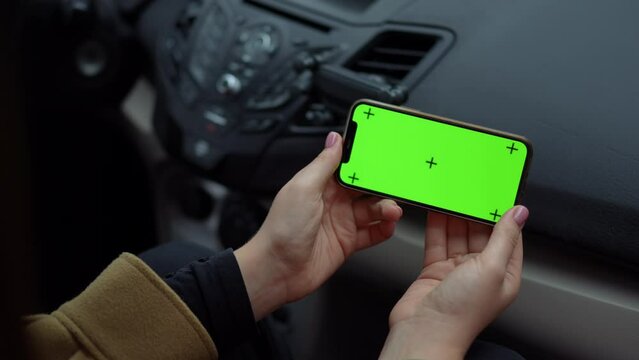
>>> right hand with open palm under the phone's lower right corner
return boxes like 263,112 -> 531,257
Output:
380,206 -> 528,359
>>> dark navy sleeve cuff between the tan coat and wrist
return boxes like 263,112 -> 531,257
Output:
165,249 -> 258,354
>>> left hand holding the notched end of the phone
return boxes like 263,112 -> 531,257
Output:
235,132 -> 402,320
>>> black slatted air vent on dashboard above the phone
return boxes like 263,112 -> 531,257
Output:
346,31 -> 440,82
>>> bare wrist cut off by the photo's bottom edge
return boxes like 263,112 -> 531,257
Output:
380,319 -> 472,360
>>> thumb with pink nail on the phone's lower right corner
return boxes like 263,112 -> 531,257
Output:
482,205 -> 528,268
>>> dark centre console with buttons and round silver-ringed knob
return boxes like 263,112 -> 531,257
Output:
151,0 -> 447,190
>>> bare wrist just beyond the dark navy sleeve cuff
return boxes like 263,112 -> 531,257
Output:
234,233 -> 286,321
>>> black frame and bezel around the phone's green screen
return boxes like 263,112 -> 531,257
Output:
335,99 -> 533,225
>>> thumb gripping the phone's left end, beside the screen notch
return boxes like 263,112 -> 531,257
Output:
298,131 -> 342,191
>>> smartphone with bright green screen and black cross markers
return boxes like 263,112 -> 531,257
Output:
336,100 -> 532,225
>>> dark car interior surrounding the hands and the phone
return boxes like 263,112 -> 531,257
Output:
8,0 -> 639,360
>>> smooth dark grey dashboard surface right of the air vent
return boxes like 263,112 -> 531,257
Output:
392,0 -> 639,263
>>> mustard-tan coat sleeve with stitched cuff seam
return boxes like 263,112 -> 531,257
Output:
25,253 -> 218,359
